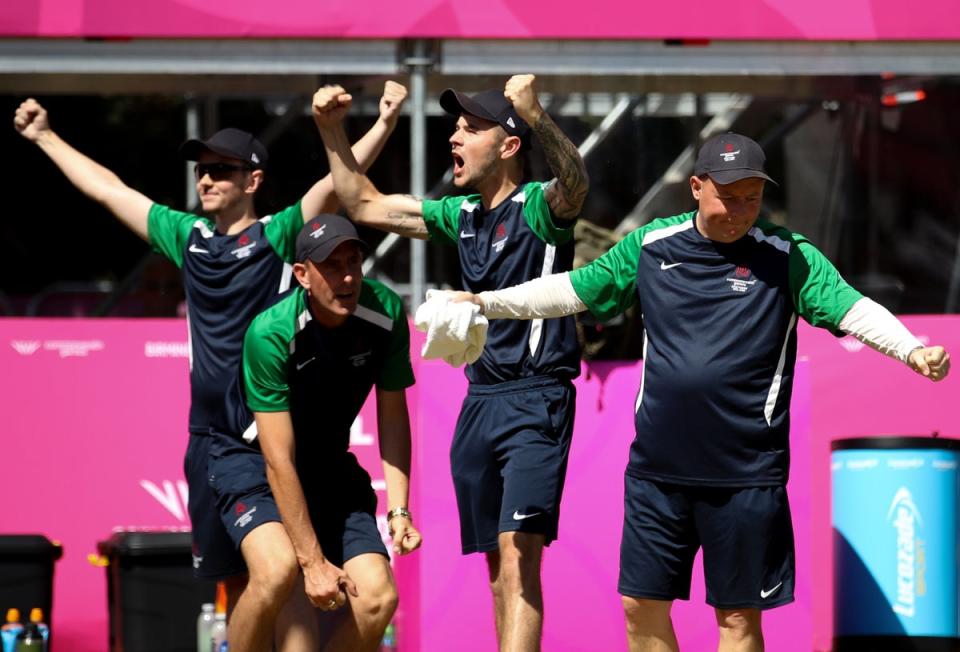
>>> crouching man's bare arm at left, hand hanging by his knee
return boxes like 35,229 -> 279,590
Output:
254,412 -> 357,609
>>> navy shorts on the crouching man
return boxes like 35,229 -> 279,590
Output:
210,442 -> 387,566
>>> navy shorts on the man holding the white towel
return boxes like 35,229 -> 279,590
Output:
618,475 -> 795,609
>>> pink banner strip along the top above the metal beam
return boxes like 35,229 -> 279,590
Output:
0,0 -> 960,41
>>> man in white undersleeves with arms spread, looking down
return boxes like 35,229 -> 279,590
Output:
458,133 -> 949,651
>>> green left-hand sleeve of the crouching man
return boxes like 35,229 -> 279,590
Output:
243,311 -> 290,412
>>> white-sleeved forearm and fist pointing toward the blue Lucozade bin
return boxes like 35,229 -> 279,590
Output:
840,297 -> 950,382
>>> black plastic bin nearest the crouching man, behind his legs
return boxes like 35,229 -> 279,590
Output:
97,532 -> 216,652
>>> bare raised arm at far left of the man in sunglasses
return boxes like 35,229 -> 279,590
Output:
13,98 -> 153,240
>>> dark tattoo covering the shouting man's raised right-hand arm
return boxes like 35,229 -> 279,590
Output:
533,112 -> 590,219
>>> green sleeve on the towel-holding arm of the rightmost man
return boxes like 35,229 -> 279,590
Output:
570,228 -> 644,320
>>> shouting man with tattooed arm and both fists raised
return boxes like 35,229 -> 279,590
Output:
314,75 -> 588,651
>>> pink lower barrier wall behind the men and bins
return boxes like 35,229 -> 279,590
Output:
0,316 -> 960,652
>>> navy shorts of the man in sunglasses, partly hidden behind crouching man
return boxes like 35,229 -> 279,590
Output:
183,433 -> 247,580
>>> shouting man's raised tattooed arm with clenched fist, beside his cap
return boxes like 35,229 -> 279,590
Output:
503,75 -> 590,219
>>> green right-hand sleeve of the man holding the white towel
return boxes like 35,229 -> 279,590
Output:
790,234 -> 863,335
